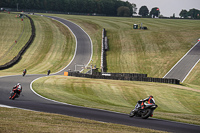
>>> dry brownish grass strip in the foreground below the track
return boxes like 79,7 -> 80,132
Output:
0,107 -> 164,133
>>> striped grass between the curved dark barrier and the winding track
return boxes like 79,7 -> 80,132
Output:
0,16 -> 75,75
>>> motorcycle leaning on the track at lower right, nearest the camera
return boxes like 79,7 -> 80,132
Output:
129,101 -> 158,119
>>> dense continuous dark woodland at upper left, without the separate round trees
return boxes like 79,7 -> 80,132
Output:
0,0 -> 133,16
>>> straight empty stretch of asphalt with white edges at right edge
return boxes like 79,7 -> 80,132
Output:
164,42 -> 200,82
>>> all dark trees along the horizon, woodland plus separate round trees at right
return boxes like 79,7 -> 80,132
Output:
0,0 -> 200,19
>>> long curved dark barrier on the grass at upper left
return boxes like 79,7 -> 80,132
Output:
0,15 -> 35,70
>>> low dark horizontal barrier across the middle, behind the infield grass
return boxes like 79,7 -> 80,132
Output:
68,72 -> 180,84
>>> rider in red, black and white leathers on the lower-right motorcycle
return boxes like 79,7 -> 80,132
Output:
133,95 -> 155,115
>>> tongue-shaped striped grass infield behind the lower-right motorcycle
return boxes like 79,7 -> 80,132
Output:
33,76 -> 200,125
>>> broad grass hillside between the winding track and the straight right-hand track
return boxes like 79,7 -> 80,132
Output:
51,15 -> 200,77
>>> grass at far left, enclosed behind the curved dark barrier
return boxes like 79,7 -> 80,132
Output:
0,13 -> 31,65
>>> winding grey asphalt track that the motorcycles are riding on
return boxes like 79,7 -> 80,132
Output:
0,15 -> 200,133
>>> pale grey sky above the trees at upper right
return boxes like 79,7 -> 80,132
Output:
123,0 -> 200,17
